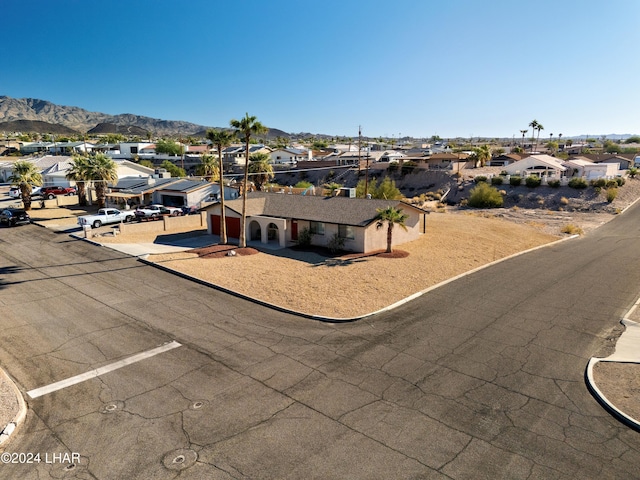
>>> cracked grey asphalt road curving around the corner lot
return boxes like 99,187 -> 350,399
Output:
0,206 -> 640,479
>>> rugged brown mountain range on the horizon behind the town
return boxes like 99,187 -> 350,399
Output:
0,96 -> 289,137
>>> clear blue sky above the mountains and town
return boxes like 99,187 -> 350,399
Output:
0,0 -> 640,138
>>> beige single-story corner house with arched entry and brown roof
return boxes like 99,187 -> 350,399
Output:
205,192 -> 428,253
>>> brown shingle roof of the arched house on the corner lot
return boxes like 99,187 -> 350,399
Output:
215,192 -> 427,226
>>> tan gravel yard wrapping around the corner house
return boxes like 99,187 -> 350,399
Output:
149,214 -> 558,318
